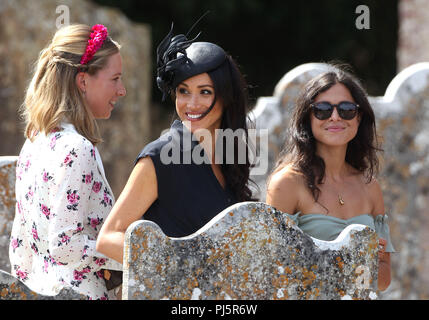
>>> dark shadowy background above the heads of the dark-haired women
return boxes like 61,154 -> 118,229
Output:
95,0 -> 398,108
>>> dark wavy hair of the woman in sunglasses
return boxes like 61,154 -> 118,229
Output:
273,66 -> 382,202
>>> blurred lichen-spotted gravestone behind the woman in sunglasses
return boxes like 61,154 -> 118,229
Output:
252,62 -> 429,299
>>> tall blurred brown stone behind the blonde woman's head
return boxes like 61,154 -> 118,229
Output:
0,0 -> 152,197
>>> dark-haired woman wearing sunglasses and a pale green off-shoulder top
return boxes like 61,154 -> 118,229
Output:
266,67 -> 394,290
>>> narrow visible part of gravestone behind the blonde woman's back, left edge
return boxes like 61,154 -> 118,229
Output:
0,157 -> 18,271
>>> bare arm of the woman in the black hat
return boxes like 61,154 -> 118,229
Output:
96,157 -> 158,263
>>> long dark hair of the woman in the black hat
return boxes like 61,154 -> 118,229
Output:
171,55 -> 256,202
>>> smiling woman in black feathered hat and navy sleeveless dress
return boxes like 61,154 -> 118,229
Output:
97,21 -> 252,262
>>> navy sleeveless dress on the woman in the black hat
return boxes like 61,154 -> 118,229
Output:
135,120 -> 237,237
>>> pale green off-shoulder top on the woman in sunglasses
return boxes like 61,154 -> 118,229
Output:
286,212 -> 395,252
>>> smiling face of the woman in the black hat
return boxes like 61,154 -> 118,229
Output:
176,73 -> 223,134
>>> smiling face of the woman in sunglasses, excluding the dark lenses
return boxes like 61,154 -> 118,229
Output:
310,83 -> 360,146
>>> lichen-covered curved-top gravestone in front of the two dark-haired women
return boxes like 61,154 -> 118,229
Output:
123,202 -> 378,300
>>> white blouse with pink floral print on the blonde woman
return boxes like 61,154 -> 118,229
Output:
9,123 -> 122,300
